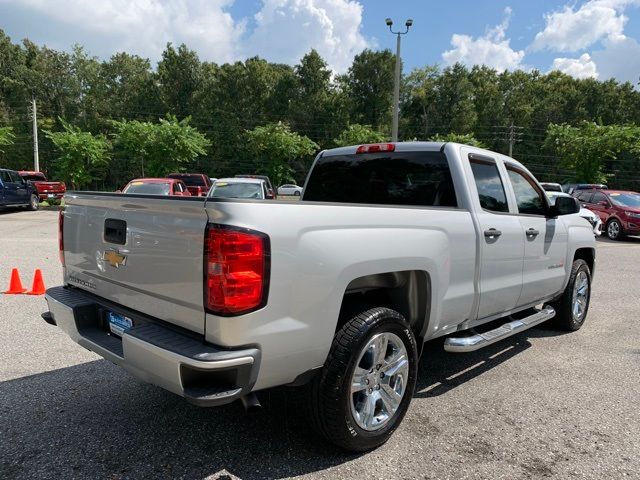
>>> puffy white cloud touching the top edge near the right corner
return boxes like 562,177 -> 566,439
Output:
530,0 -> 640,52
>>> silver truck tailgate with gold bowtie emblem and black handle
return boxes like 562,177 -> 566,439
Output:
64,192 -> 207,333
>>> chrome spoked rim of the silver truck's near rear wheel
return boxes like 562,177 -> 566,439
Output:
351,332 -> 409,431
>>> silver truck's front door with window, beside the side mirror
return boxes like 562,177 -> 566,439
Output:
506,164 -> 571,306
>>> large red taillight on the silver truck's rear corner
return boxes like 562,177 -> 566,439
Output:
204,225 -> 270,316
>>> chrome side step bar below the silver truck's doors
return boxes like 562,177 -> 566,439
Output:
444,306 -> 556,353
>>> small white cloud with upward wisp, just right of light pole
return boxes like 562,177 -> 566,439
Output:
442,7 -> 524,71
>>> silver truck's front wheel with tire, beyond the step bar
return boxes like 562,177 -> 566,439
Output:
551,259 -> 591,332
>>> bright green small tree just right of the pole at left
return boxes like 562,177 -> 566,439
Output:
45,119 -> 111,190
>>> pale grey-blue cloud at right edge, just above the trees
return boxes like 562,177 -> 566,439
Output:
591,36 -> 640,85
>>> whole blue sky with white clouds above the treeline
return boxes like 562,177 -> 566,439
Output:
0,0 -> 640,83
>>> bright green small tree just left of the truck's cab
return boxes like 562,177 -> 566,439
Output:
246,122 -> 320,185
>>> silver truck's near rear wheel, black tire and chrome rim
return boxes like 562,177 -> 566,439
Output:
309,307 -> 418,452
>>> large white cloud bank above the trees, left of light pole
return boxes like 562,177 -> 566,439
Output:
0,0 -> 371,72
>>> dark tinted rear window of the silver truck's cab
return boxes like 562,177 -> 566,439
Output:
304,152 -> 458,207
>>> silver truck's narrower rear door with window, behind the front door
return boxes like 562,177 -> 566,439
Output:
463,150 -> 524,318
